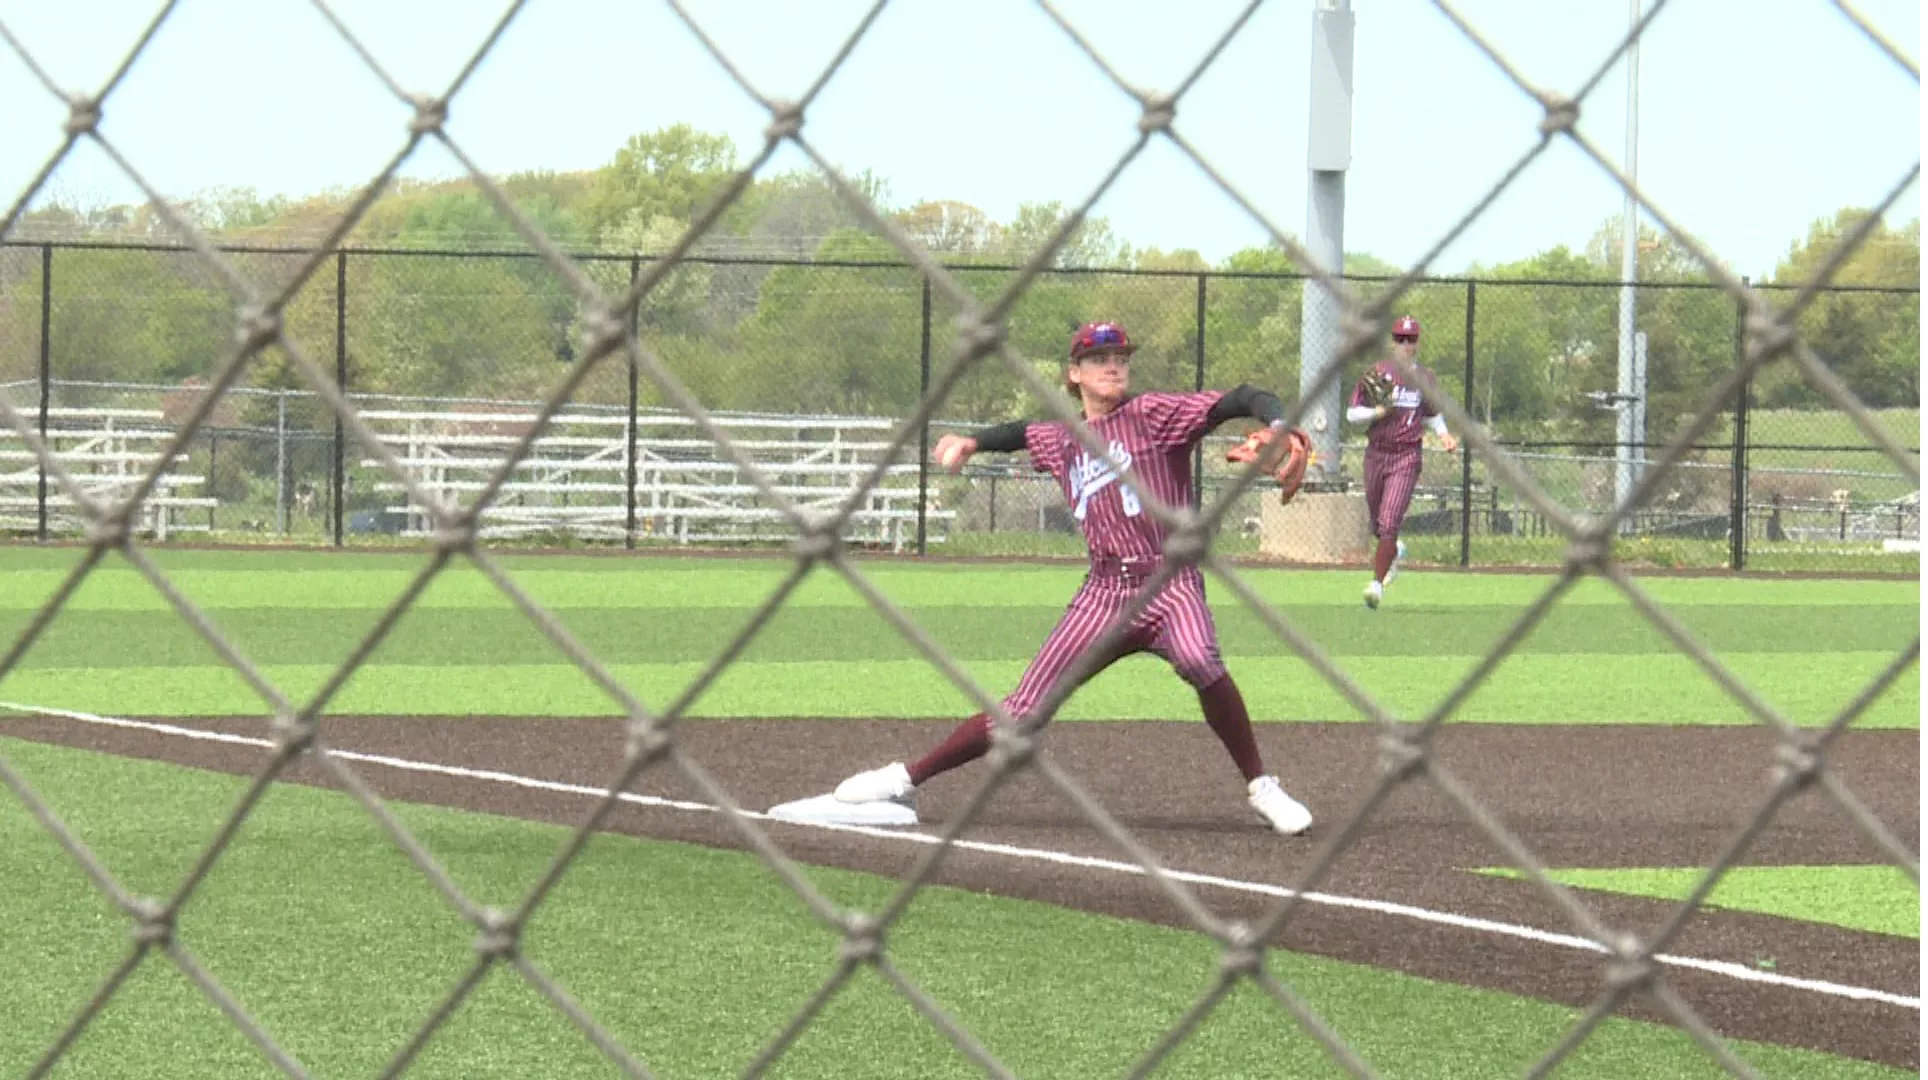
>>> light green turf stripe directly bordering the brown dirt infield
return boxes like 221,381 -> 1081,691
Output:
0,652 -> 1920,729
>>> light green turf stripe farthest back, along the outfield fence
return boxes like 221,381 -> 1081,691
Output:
0,548 -> 1920,613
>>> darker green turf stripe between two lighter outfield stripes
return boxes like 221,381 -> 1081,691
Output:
0,602 -> 1918,667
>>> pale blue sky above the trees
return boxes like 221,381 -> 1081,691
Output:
0,0 -> 1920,278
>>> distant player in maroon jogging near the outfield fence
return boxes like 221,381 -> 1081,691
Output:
1346,314 -> 1459,609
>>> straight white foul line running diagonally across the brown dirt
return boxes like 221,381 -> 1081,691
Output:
0,702 -> 1922,1013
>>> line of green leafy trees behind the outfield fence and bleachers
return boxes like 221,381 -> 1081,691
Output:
0,125 -> 1920,440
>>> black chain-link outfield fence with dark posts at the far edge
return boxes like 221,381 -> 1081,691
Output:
0,241 -> 1920,573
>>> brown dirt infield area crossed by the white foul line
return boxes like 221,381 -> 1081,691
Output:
0,717 -> 1920,1068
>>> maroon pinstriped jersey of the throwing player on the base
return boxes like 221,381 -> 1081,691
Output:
1024,390 -> 1224,557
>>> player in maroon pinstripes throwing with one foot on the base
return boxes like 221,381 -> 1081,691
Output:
835,322 -> 1313,835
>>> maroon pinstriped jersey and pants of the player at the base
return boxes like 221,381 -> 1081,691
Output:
1004,390 -> 1226,717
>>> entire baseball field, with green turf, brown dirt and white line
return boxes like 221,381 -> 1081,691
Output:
0,548 -> 1920,1078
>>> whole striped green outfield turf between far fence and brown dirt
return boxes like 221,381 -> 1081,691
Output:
0,548 -> 1920,727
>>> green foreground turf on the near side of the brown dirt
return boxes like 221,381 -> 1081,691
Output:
0,739 -> 1907,1080
